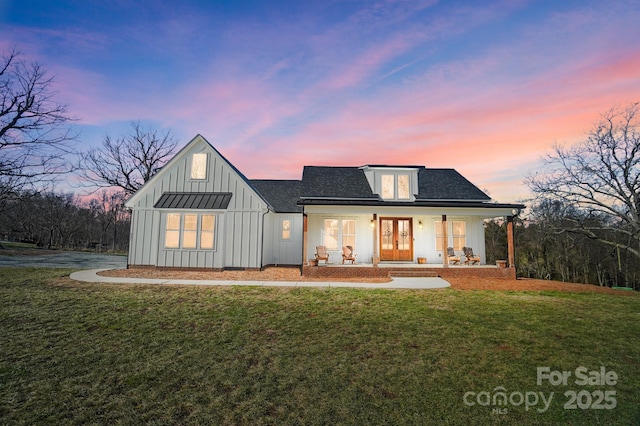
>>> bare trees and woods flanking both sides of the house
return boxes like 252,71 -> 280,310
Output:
0,49 -> 640,289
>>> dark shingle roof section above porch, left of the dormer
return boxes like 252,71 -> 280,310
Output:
300,166 -> 379,200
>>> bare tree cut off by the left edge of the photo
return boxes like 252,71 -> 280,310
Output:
0,49 -> 76,206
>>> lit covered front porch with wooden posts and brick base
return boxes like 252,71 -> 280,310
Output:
302,205 -> 519,279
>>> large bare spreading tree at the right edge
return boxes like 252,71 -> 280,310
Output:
525,103 -> 640,258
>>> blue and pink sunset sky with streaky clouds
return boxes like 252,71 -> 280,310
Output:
0,0 -> 640,202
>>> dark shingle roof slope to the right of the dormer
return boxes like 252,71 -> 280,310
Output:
416,168 -> 491,201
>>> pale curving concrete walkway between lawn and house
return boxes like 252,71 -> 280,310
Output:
71,269 -> 451,289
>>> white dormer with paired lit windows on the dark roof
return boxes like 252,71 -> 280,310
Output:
361,166 -> 422,202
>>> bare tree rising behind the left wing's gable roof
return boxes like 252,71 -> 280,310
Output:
82,121 -> 177,194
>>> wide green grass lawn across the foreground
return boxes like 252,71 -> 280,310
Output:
0,268 -> 640,425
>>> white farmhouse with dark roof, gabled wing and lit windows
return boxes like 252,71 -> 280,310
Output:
126,135 -> 524,276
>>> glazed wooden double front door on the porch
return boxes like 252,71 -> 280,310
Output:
380,217 -> 413,261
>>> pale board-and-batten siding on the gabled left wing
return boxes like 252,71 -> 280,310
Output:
127,135 -> 268,268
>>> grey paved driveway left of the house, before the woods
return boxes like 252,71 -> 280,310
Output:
0,251 -> 127,269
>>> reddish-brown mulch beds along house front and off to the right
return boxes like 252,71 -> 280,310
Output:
100,267 -> 636,296
